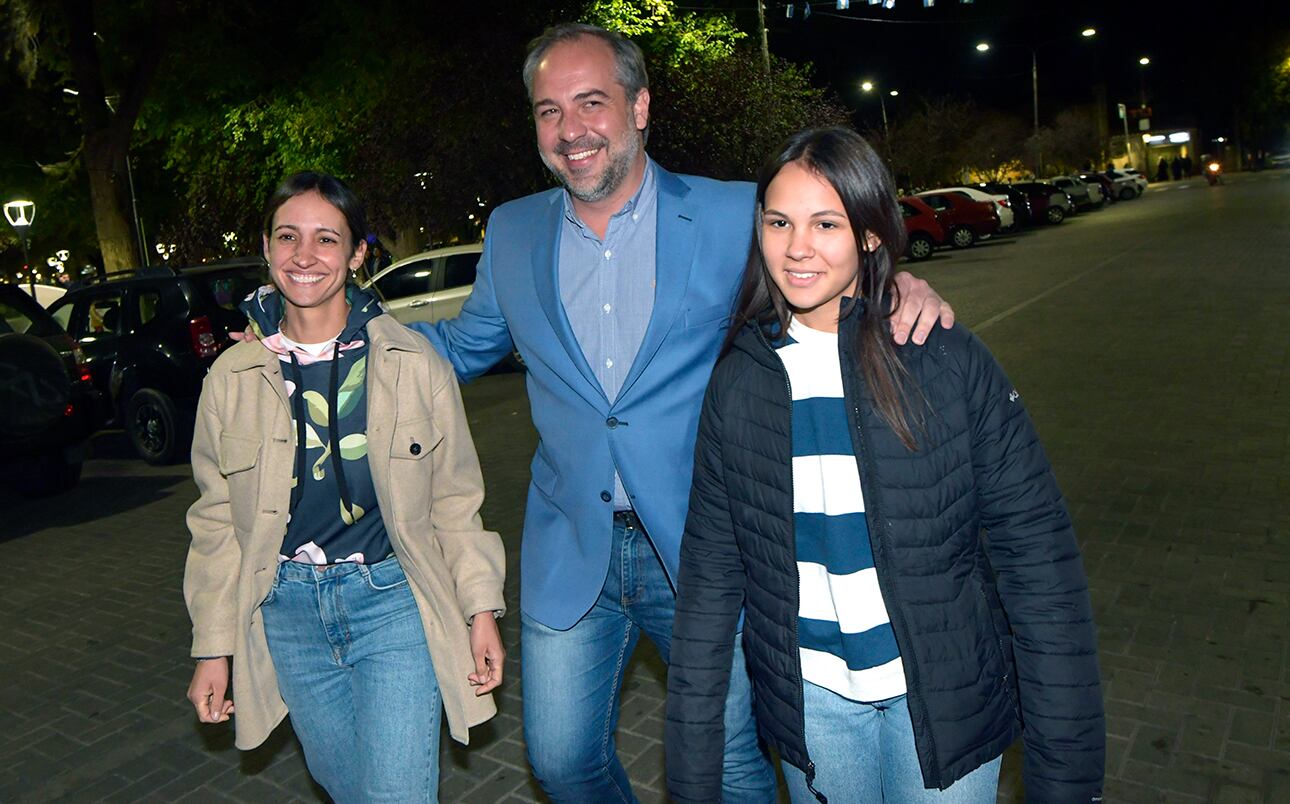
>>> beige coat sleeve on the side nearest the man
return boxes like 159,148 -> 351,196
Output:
427,354 -> 506,619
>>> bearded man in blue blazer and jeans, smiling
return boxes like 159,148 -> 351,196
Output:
414,25 -> 952,803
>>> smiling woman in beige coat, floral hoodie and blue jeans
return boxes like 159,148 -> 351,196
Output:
184,173 -> 504,803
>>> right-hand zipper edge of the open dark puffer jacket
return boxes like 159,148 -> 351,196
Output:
837,317 -> 940,786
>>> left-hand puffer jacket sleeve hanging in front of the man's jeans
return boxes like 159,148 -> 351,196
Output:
664,377 -> 744,801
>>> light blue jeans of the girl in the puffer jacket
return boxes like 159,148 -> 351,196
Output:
782,681 -> 1002,804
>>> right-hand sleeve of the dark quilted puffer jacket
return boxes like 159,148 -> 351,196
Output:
964,334 -> 1106,801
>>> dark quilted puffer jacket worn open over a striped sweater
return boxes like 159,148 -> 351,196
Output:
666,307 -> 1106,803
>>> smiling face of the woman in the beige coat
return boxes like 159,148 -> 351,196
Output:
264,191 -> 368,321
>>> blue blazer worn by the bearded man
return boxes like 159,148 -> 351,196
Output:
413,165 -> 755,630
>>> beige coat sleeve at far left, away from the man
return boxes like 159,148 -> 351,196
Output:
183,374 -> 241,658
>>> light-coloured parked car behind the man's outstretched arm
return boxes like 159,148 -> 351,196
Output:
362,243 -> 524,369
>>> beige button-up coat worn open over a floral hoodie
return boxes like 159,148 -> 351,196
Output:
183,315 -> 506,750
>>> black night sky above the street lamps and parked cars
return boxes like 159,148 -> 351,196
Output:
753,0 -> 1290,141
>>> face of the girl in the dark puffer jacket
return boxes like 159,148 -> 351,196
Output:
761,163 -> 877,332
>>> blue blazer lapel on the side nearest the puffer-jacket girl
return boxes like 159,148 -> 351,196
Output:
618,164 -> 698,399
